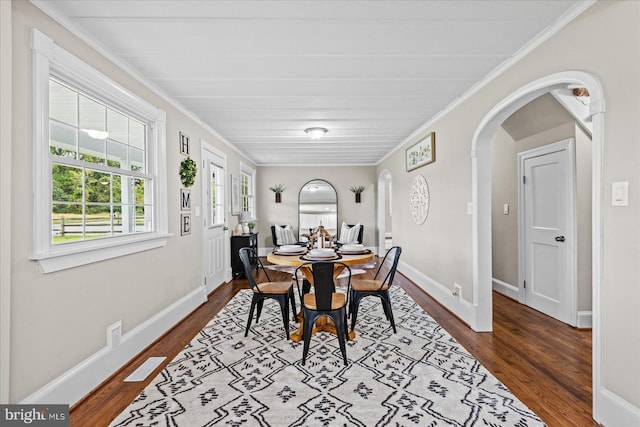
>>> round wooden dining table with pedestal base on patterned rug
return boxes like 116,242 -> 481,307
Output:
267,247 -> 374,342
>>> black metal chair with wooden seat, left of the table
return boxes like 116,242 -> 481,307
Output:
239,247 -> 296,339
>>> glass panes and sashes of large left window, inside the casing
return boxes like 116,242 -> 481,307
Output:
49,76 -> 153,245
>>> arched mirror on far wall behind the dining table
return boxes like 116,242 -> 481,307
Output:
298,179 -> 338,241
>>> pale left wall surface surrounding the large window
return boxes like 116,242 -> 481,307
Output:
3,1 -> 251,403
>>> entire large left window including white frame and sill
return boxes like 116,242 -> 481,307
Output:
32,30 -> 167,272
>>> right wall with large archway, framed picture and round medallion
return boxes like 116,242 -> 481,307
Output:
378,1 -> 640,419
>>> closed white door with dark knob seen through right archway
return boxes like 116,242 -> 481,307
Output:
520,140 -> 576,324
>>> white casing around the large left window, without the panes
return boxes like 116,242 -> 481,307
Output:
30,29 -> 169,273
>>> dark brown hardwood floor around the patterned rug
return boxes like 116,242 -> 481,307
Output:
70,260 -> 598,427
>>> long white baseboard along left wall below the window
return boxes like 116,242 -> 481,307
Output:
20,286 -> 207,405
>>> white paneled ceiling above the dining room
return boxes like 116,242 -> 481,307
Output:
33,0 -> 579,165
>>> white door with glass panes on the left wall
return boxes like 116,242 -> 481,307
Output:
202,144 -> 229,294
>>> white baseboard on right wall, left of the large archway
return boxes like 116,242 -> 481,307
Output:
398,260 -> 477,327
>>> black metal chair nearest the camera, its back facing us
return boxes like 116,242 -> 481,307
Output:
293,261 -> 351,366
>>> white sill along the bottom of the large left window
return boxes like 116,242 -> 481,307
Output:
31,234 -> 171,273
